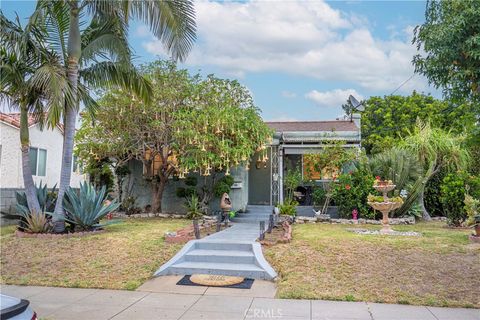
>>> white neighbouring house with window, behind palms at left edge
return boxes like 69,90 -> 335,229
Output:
0,113 -> 85,214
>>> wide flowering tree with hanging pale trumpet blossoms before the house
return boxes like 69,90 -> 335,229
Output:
77,61 -> 271,212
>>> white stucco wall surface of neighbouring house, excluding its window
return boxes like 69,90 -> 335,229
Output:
0,122 -> 85,188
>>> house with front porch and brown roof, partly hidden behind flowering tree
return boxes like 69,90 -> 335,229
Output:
124,117 -> 361,213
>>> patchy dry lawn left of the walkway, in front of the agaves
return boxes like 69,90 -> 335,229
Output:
0,219 -> 190,290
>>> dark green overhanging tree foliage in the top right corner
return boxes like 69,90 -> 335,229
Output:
413,0 -> 480,102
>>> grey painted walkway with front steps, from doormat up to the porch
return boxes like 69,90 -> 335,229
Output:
154,206 -> 277,280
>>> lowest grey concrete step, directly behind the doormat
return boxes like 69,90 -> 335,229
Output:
170,261 -> 269,279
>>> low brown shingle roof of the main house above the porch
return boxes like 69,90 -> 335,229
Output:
266,120 -> 359,132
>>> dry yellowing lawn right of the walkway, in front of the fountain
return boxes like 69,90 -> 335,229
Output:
265,223 -> 480,307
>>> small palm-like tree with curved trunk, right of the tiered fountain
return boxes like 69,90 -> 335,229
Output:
401,120 -> 469,220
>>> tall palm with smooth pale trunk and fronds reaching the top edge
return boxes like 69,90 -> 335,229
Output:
34,0 -> 195,232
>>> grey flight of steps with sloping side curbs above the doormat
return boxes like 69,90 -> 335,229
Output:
155,239 -> 277,280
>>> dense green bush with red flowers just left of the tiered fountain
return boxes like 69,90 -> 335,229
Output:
330,164 -> 375,219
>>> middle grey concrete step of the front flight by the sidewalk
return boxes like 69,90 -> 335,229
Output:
185,249 -> 255,264
